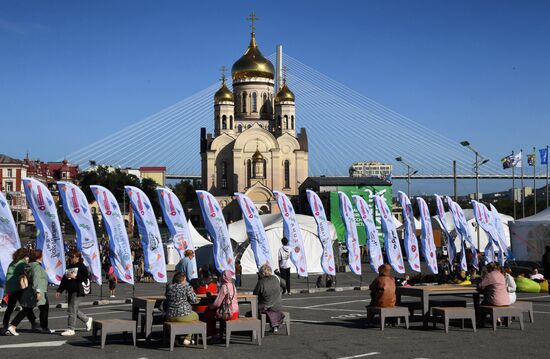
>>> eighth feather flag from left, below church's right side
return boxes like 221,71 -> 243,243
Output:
235,193 -> 275,270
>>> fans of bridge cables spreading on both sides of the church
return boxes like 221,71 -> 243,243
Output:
67,54 -> 546,179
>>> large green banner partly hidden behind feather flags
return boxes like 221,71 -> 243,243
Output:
330,186 -> 392,245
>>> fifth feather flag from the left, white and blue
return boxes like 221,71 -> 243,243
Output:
124,186 -> 166,283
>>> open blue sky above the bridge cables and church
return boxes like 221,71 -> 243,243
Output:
0,0 -> 550,197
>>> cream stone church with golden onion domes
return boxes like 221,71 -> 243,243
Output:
200,21 -> 308,220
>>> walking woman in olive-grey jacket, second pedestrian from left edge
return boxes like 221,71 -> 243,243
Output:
7,249 -> 54,336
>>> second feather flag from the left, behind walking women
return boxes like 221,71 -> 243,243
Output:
23,178 -> 65,284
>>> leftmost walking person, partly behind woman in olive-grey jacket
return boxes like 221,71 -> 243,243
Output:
2,248 -> 36,331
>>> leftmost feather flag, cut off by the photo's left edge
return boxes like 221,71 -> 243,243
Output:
0,193 -> 21,286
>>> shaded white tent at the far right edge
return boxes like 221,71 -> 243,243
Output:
510,208 -> 550,261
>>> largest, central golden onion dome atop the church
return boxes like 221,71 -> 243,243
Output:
231,33 -> 275,81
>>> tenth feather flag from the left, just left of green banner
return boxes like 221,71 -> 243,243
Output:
306,189 -> 336,275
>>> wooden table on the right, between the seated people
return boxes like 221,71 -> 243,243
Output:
396,284 -> 479,327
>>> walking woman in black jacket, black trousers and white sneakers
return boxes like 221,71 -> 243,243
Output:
55,250 -> 93,336
